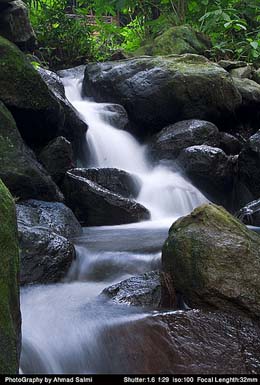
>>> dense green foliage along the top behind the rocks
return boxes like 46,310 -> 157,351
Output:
27,0 -> 260,66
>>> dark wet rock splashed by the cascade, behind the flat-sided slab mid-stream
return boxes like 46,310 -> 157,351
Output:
72,168 -> 142,198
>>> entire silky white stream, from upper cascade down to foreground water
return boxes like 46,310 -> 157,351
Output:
21,71 -> 207,374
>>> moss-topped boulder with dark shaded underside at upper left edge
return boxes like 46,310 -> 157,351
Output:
0,37 -> 64,147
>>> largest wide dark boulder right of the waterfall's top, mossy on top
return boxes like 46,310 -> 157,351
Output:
83,54 -> 241,136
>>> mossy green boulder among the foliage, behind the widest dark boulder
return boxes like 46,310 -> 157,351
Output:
134,25 -> 211,56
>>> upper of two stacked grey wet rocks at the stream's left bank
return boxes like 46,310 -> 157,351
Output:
16,199 -> 81,239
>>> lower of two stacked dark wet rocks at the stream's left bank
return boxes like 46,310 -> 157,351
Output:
18,225 -> 75,285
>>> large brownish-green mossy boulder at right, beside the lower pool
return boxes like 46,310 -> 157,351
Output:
162,204 -> 260,318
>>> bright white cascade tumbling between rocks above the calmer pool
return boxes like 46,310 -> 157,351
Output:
63,77 -> 207,220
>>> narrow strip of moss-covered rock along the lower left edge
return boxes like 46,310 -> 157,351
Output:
0,180 -> 21,374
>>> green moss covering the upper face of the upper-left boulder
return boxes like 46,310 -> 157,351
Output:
0,37 -> 53,110
